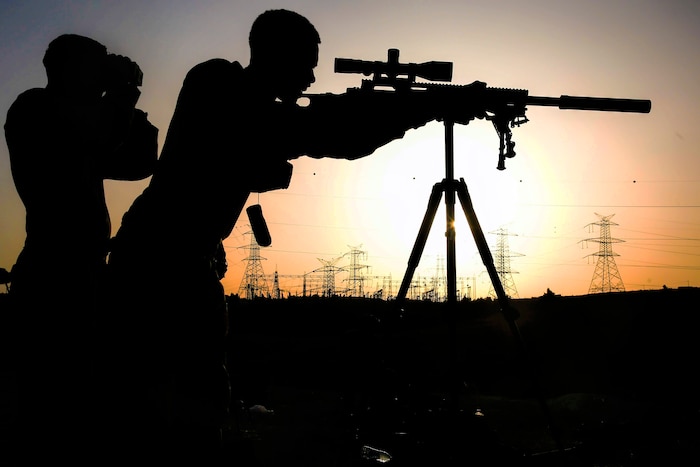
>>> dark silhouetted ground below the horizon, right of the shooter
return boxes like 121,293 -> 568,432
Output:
221,288 -> 700,466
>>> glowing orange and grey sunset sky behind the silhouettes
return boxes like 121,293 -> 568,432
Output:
0,0 -> 700,297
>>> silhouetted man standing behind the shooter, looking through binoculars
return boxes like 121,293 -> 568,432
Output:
5,34 -> 158,465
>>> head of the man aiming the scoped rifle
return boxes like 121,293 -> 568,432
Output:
248,9 -> 321,102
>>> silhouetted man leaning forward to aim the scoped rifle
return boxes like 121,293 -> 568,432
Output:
110,10 -> 484,459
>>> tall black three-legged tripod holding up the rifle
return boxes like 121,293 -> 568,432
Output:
396,120 -> 562,456
